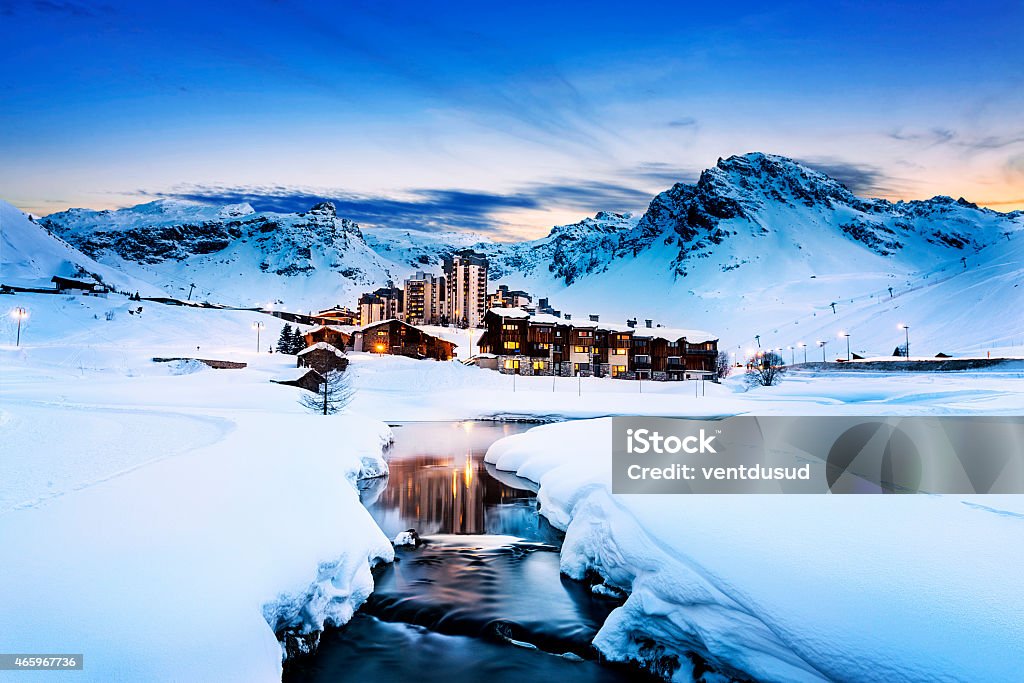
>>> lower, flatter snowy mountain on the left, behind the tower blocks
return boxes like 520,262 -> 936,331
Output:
42,200 -> 405,310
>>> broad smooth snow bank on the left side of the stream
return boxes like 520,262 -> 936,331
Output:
0,295 -> 393,682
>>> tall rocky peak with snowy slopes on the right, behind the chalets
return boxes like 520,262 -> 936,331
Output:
481,154 -> 1024,355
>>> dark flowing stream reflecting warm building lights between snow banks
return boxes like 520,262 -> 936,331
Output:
285,422 -> 647,683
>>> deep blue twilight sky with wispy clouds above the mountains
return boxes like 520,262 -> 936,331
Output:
0,0 -> 1024,237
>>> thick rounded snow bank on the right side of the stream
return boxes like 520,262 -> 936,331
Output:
486,420 -> 1024,681
